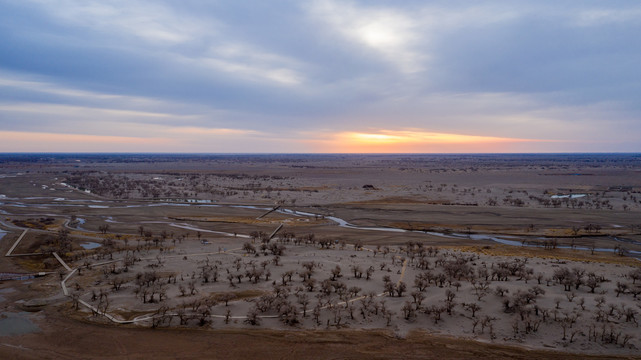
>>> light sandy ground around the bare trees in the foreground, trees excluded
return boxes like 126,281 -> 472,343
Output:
53,240 -> 640,354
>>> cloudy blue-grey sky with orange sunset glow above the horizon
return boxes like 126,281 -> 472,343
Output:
0,0 -> 641,153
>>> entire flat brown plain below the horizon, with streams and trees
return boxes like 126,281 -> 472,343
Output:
0,155 -> 641,359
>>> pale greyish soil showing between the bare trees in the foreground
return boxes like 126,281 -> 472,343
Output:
56,239 -> 641,354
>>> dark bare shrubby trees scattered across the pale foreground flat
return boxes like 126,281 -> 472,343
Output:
66,225 -> 641,352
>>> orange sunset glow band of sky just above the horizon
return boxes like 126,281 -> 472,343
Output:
0,127 -> 556,153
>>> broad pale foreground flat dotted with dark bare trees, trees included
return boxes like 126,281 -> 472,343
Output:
58,235 -> 641,354
